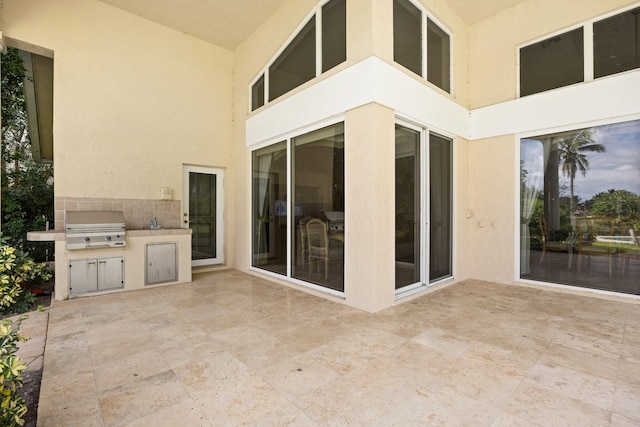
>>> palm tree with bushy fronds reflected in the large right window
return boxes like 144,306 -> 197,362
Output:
558,128 -> 606,217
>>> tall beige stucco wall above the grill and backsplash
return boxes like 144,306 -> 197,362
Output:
1,0 -> 233,204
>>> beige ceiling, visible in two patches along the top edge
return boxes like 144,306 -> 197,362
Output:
101,0 -> 525,50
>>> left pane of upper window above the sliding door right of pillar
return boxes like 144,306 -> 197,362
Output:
393,0 -> 422,76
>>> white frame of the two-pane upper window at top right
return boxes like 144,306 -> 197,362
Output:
515,2 -> 640,98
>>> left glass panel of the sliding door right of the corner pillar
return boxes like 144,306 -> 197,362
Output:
395,125 -> 421,289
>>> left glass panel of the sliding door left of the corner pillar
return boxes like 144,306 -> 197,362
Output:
252,142 -> 287,275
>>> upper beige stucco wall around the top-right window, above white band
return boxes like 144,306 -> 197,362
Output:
469,0 -> 637,109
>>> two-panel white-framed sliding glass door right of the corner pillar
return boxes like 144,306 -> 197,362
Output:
395,124 -> 453,292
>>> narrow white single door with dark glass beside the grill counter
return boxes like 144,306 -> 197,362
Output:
182,166 -> 224,267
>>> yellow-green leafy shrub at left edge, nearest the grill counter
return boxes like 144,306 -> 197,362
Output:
0,237 -> 39,314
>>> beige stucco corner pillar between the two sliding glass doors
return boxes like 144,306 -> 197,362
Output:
344,104 -> 395,312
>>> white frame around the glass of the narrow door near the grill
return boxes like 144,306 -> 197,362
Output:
182,165 -> 225,267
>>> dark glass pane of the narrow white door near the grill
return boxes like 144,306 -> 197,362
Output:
189,172 -> 217,260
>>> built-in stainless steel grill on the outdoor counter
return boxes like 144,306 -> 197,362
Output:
65,211 -> 127,250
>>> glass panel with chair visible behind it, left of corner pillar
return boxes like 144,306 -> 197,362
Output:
291,123 -> 345,291
